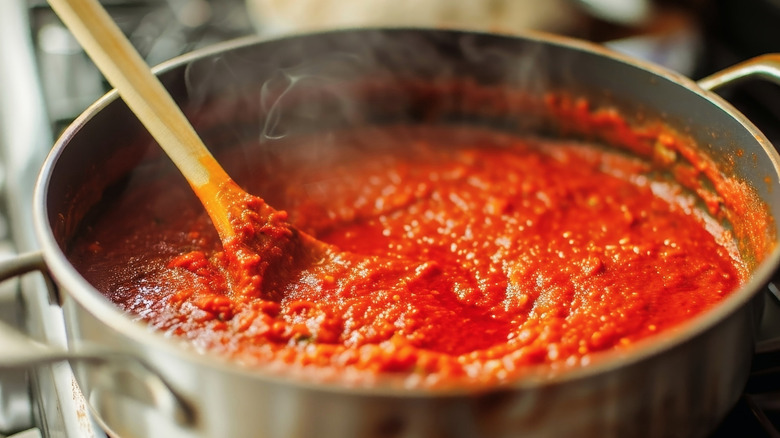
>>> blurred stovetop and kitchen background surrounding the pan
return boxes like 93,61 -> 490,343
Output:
0,0 -> 780,438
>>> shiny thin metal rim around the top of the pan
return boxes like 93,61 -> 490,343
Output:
33,28 -> 780,397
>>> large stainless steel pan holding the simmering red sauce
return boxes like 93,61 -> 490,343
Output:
0,29 -> 780,437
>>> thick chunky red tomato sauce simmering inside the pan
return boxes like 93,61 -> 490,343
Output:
69,127 -> 745,385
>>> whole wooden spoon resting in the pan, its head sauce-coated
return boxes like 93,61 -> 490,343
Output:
49,0 -> 328,298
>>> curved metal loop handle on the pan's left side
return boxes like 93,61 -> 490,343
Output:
0,252 -> 196,427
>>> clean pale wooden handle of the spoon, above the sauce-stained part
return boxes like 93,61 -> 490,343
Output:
49,0 -> 230,189
